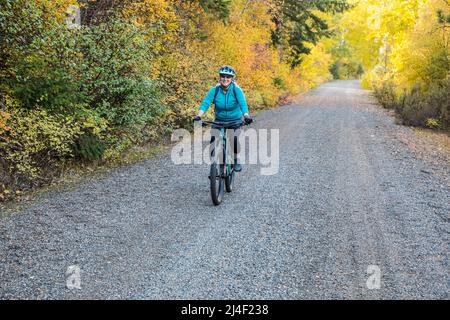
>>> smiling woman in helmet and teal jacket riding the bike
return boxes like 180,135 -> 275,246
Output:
194,66 -> 253,172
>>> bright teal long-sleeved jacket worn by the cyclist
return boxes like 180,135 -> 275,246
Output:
200,82 -> 248,121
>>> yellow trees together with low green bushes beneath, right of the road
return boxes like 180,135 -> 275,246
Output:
332,0 -> 450,132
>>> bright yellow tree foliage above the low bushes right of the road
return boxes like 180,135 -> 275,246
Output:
340,0 -> 450,90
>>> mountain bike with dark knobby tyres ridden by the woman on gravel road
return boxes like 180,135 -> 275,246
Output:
202,120 -> 250,206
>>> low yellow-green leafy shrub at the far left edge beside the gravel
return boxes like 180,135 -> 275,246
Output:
0,104 -> 82,187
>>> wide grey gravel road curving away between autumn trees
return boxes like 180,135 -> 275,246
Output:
0,81 -> 450,299
